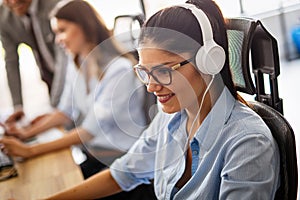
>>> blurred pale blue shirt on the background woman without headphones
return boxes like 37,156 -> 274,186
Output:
58,57 -> 146,151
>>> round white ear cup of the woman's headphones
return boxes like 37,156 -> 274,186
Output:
195,40 -> 226,75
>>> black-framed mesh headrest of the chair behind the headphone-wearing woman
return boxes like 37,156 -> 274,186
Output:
227,17 -> 283,114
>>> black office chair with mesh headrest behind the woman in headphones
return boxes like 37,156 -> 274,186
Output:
226,18 -> 298,200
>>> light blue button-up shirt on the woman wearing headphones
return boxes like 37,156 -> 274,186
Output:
110,88 -> 280,200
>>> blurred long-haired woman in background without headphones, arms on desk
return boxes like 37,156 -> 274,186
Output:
1,0 -> 146,177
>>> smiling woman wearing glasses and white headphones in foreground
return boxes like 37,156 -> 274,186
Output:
7,0 -> 279,199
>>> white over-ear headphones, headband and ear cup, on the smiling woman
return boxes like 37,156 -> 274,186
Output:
176,3 -> 226,75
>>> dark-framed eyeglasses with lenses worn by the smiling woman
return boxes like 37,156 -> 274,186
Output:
133,58 -> 193,85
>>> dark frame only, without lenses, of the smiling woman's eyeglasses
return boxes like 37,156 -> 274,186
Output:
133,57 -> 194,86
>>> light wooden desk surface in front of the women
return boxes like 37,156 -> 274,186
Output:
0,130 -> 83,200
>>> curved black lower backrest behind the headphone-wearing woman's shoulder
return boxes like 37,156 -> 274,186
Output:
248,101 -> 298,200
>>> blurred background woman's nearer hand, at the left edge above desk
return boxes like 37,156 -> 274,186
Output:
0,137 -> 32,158
